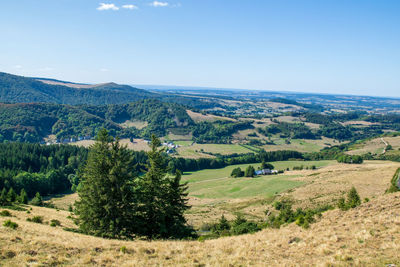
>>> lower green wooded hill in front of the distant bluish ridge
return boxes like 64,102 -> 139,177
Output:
0,99 -> 194,143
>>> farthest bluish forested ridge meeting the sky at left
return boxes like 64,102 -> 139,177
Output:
0,72 -> 158,105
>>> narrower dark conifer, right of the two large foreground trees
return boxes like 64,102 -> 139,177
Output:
140,135 -> 192,238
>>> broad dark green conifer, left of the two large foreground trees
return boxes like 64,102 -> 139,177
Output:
75,129 -> 142,238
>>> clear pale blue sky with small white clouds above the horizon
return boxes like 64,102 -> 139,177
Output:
0,0 -> 400,96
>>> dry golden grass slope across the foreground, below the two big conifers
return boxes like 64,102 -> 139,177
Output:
0,193 -> 400,266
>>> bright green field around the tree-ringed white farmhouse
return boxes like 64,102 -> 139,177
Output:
183,160 -> 335,199
